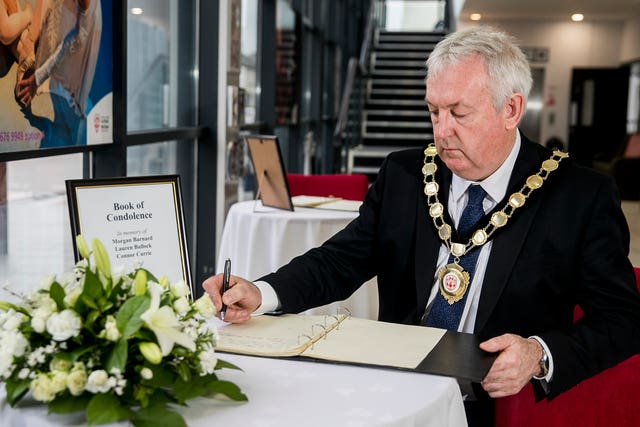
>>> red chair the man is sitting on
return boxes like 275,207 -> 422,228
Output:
495,267 -> 640,427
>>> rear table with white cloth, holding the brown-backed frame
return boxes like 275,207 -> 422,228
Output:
216,201 -> 378,319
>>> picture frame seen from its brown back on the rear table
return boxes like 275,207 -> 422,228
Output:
244,135 -> 293,211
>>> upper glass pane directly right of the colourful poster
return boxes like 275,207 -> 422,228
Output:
127,0 -> 198,131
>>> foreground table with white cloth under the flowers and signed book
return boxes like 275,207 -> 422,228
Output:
0,353 -> 467,427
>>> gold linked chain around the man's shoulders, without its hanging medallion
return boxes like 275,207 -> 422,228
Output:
422,144 -> 569,258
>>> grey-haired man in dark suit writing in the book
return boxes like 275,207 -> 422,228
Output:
203,27 -> 640,424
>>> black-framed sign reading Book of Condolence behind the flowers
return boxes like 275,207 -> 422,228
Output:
66,175 -> 195,296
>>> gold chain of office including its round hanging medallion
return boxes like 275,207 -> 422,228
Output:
422,144 -> 569,304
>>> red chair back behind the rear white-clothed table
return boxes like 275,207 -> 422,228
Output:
287,173 -> 369,200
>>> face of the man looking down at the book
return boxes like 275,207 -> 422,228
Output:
426,55 -> 522,181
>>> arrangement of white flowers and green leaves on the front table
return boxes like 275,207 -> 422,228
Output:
0,236 -> 247,426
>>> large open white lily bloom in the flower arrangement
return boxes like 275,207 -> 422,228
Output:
140,282 -> 196,356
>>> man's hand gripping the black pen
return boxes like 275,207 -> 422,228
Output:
202,274 -> 262,323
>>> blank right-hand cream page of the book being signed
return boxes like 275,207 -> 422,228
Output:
303,317 -> 446,369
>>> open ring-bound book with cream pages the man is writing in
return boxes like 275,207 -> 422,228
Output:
216,314 -> 493,381
